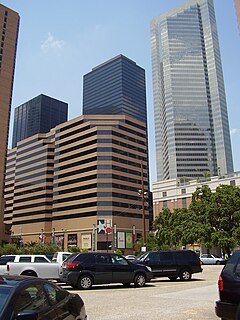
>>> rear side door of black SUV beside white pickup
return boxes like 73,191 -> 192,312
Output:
94,253 -> 112,283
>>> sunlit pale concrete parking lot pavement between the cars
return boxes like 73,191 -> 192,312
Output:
63,265 -> 223,320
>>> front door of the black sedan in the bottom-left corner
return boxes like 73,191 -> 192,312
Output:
13,284 -> 58,320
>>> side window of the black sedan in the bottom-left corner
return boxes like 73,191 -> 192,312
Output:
14,285 -> 49,314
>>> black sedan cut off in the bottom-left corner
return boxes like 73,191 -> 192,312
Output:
0,275 -> 87,320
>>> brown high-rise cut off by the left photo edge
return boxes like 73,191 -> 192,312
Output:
0,4 -> 19,244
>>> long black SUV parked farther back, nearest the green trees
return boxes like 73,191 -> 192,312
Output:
136,250 -> 202,280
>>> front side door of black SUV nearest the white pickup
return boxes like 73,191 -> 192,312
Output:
111,254 -> 134,283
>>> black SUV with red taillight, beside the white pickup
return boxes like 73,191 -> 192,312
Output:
62,252 -> 153,289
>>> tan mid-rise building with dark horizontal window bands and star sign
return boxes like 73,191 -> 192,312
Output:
4,115 -> 149,252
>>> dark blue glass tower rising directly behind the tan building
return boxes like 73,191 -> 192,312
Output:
83,54 -> 147,123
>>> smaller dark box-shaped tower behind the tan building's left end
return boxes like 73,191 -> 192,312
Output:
12,94 -> 68,148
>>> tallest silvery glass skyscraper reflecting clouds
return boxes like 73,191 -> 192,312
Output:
151,0 -> 233,181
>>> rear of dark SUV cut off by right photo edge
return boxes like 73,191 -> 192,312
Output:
215,250 -> 240,320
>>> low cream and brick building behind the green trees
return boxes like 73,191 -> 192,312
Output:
152,172 -> 240,219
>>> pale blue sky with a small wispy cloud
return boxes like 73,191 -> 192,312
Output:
1,0 -> 240,182
